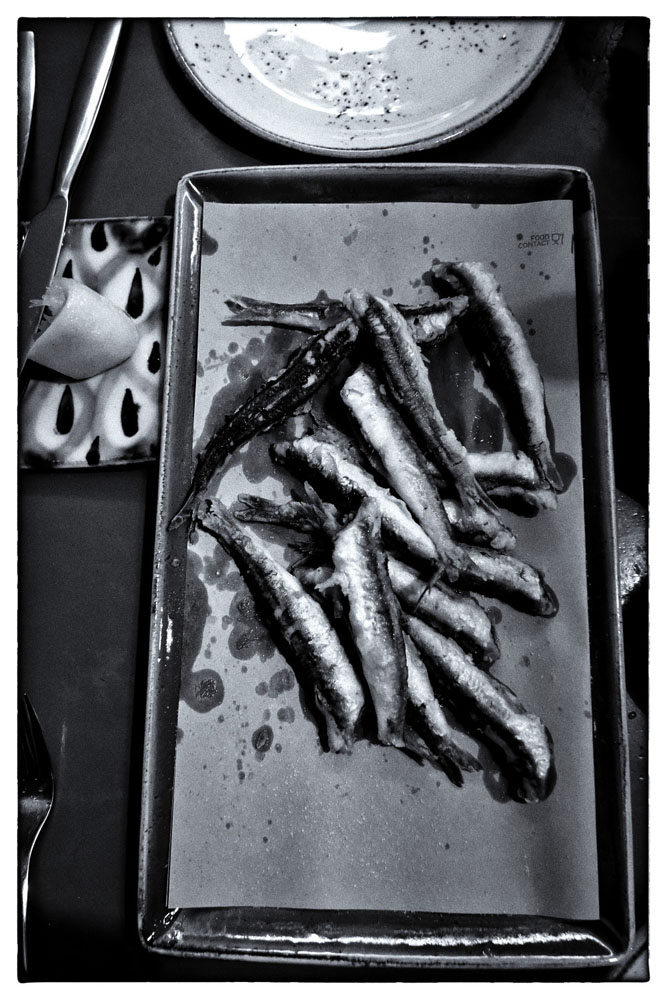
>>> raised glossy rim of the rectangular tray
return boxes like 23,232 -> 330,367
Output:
138,162 -> 635,970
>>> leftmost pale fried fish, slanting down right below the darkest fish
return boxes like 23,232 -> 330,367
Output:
198,500 -> 364,751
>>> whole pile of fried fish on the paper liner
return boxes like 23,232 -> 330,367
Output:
170,262 -> 563,802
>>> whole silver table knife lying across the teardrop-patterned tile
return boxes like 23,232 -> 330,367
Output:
18,18 -> 123,376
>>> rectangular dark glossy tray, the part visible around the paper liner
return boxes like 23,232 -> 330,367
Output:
138,164 -> 634,974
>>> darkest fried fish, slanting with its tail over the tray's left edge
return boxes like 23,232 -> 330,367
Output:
169,319 -> 358,529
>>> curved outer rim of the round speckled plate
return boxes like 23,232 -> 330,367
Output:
163,16 -> 564,160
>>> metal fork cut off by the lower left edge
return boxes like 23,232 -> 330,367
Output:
18,693 -> 53,971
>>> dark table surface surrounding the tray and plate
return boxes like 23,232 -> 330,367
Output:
18,18 -> 649,982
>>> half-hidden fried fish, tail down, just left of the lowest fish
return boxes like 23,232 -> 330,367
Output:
404,634 -> 481,787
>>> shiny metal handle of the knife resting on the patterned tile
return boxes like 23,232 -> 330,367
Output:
53,18 -> 123,198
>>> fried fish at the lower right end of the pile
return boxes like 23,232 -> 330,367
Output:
404,616 -> 556,802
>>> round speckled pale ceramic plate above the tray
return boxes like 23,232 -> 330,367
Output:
166,18 -> 561,157
